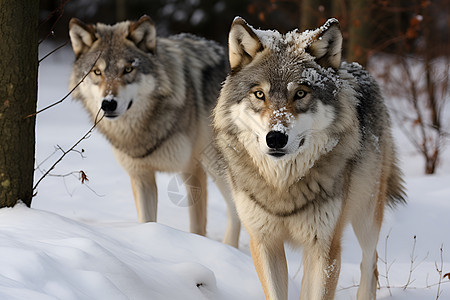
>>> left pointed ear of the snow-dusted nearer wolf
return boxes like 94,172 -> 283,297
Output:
228,17 -> 264,71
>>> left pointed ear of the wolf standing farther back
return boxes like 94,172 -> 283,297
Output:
69,18 -> 97,58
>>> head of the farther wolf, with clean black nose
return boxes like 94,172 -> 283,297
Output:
69,16 -> 156,119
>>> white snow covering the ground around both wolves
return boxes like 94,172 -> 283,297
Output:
0,46 -> 450,300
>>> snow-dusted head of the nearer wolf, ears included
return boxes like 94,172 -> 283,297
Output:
216,17 -> 342,160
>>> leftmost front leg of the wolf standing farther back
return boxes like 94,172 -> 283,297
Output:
130,172 -> 158,223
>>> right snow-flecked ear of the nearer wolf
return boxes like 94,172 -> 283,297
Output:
306,19 -> 342,69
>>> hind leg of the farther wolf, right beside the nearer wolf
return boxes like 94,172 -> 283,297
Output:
215,176 -> 241,248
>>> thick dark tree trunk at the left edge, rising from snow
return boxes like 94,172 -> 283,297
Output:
0,0 -> 39,207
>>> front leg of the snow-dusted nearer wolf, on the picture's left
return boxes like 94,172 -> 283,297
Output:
250,233 -> 288,300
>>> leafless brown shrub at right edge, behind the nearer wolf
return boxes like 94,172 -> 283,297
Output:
373,0 -> 450,174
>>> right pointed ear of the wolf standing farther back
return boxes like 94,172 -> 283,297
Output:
128,15 -> 156,53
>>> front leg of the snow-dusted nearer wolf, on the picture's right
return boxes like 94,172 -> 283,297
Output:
300,241 -> 341,300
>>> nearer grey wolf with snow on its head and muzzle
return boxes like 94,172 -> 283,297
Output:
213,17 -> 405,300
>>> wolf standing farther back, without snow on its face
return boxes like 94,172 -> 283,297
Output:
69,15 -> 240,247
